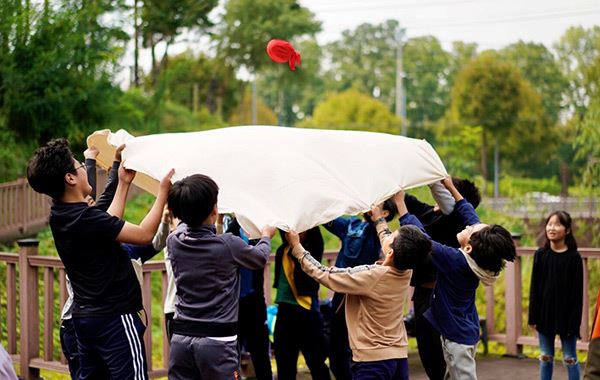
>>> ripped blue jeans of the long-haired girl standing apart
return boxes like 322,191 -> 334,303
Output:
538,332 -> 579,380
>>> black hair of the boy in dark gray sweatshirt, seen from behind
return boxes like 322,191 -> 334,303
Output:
167,174 -> 219,227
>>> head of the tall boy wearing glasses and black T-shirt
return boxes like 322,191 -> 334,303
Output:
27,139 -> 92,200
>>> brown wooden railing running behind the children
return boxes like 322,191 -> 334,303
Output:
0,239 -> 600,379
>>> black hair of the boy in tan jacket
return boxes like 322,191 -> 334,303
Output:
392,225 -> 431,270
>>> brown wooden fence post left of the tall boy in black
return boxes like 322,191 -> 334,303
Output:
18,239 -> 40,380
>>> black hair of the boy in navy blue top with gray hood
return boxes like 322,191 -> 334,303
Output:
469,224 -> 517,275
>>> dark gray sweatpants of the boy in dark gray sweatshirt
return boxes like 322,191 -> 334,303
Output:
169,334 -> 242,380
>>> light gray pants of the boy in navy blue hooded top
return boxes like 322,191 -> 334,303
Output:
441,336 -> 477,380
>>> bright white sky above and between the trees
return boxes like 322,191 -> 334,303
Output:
118,0 -> 600,87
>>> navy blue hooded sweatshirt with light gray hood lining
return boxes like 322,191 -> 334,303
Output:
400,199 -> 497,345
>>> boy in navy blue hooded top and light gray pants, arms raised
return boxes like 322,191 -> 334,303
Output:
394,177 -> 516,380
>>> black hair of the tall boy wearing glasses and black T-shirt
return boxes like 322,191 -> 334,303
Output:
27,139 -> 76,200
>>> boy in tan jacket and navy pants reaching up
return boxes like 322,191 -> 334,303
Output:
287,205 -> 431,380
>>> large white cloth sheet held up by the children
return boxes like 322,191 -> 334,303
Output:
87,126 -> 447,237
